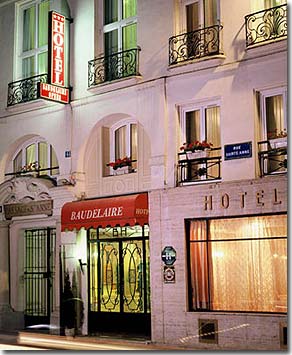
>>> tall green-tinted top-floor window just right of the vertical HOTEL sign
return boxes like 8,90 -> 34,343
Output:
104,0 -> 137,56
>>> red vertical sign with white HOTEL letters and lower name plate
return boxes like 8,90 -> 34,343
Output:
39,11 -> 70,104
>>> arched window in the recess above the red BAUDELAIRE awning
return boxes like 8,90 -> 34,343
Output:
110,121 -> 138,169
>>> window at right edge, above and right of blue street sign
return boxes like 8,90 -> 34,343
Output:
260,88 -> 287,140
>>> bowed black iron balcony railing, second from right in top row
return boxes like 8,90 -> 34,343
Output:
169,25 -> 223,65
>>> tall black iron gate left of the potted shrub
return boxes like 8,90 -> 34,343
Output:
24,228 -> 56,324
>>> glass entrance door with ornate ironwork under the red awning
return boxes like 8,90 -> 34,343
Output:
88,226 -> 150,335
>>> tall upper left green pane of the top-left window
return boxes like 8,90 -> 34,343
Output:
22,6 -> 36,52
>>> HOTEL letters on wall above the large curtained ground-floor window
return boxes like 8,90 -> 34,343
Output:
203,188 -> 282,211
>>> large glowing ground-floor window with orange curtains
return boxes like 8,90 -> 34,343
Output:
189,214 -> 287,313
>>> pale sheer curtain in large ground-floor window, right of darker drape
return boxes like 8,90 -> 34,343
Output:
210,216 -> 287,312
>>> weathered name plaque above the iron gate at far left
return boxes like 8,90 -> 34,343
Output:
4,200 -> 53,219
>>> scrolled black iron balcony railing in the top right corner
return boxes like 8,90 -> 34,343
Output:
245,4 -> 287,47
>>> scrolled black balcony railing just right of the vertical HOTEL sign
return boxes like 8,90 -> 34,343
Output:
88,48 -> 141,87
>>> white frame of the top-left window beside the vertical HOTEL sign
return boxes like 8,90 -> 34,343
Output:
14,0 -> 50,80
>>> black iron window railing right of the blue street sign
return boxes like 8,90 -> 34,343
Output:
258,141 -> 287,177
